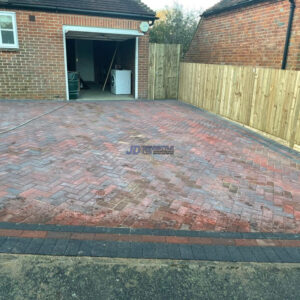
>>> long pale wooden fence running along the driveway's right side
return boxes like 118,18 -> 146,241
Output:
179,63 -> 300,147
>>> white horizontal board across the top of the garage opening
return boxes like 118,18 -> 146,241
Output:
63,25 -> 144,36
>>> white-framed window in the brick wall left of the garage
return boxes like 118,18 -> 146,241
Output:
0,12 -> 19,48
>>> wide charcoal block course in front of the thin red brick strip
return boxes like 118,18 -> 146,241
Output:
0,237 -> 300,263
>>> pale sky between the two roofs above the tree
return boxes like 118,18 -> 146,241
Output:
142,0 -> 220,10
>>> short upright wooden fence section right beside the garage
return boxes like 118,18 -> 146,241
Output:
148,44 -> 181,99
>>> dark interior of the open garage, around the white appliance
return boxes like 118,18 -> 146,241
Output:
66,38 -> 136,100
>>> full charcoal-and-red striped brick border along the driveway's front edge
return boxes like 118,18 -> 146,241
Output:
0,223 -> 300,263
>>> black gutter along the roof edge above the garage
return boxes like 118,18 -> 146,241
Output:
0,1 -> 158,22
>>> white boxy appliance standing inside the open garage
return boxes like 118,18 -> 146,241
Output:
111,70 -> 131,95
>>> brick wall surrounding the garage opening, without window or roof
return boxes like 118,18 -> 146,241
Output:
0,8 -> 149,99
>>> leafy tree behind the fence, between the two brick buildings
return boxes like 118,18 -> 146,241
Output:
150,3 -> 200,54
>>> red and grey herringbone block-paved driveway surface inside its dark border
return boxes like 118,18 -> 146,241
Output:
0,101 -> 300,234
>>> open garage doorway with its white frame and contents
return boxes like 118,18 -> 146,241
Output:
63,26 -> 144,101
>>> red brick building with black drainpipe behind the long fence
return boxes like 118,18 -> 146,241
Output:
185,0 -> 300,70
